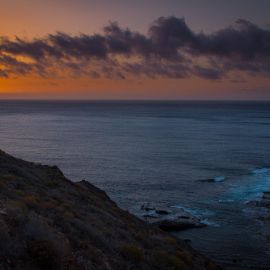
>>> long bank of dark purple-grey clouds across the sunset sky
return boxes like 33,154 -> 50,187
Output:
0,17 -> 270,80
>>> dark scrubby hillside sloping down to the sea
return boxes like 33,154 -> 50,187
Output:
0,151 -> 219,270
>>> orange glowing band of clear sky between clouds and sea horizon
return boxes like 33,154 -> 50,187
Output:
0,74 -> 270,100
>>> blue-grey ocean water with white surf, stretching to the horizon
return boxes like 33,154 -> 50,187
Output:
0,101 -> 270,269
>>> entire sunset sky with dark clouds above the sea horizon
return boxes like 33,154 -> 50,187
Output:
0,0 -> 270,100
